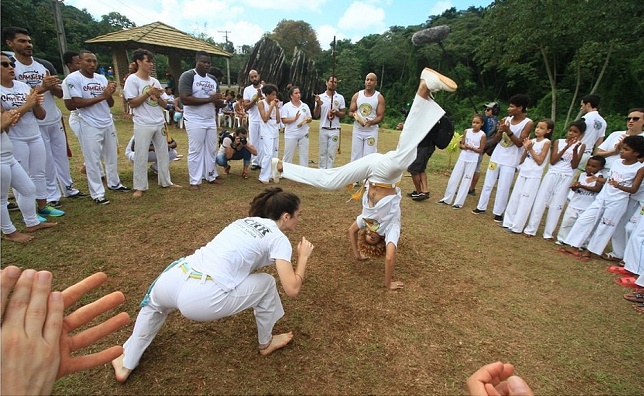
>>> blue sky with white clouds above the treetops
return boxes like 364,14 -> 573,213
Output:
64,0 -> 492,49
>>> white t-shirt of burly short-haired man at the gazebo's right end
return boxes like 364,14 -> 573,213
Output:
179,69 -> 217,127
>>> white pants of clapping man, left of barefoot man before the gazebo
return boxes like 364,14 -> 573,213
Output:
79,120 -> 121,199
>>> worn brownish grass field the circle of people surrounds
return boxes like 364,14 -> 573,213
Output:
2,96 -> 644,395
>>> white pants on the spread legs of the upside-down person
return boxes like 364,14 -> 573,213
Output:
282,95 -> 445,190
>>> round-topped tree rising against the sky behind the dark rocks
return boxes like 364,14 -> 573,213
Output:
269,19 -> 322,61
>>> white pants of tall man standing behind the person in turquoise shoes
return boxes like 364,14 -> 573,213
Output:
39,119 -> 78,201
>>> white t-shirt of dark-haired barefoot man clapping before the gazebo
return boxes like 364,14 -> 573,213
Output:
123,74 -> 168,126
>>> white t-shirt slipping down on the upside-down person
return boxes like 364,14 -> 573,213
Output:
356,183 -> 402,246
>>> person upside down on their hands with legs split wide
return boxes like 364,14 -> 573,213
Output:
271,69 -> 456,289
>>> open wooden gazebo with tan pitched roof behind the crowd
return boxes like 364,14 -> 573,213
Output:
86,22 -> 233,88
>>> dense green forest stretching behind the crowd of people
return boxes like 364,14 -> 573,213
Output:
1,0 -> 644,135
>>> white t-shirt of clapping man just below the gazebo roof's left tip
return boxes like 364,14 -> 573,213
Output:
63,70 -> 114,128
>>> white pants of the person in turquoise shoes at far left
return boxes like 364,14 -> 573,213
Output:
11,136 -> 47,199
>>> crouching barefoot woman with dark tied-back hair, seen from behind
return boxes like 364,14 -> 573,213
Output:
112,188 -> 313,382
